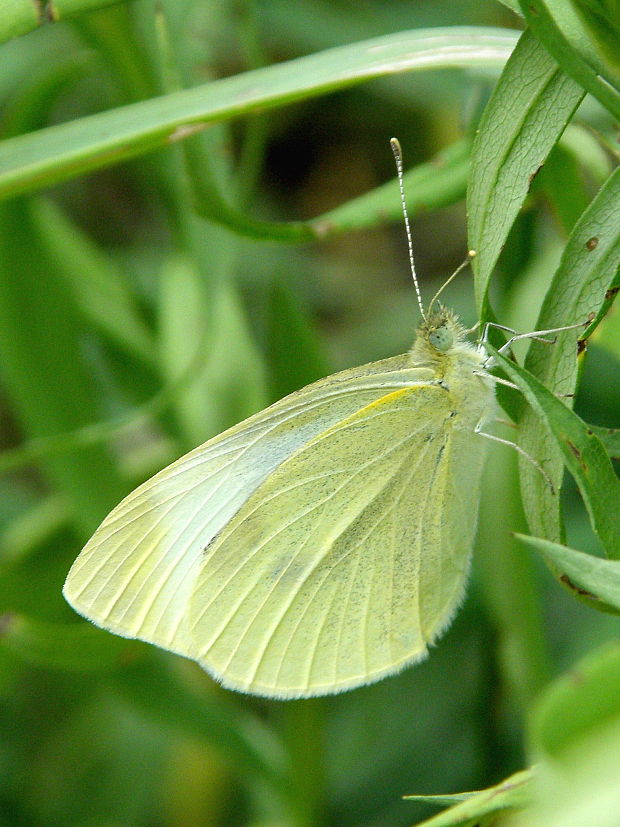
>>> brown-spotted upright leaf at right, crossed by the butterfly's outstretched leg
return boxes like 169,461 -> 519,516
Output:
519,167 -> 620,541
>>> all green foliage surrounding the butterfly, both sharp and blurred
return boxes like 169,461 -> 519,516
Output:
0,0 -> 620,827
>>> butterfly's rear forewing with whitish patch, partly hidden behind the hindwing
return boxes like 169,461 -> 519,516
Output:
64,355 -> 428,657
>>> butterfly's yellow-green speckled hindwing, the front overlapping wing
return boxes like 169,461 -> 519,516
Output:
190,384 -> 484,698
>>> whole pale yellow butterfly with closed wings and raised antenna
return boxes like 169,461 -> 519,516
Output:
64,143 -> 495,698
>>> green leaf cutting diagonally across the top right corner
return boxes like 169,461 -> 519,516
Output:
519,0 -> 620,118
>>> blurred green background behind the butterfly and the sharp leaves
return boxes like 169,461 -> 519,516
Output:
0,0 -> 620,827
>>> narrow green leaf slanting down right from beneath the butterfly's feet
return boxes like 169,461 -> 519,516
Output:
487,345 -> 620,558
